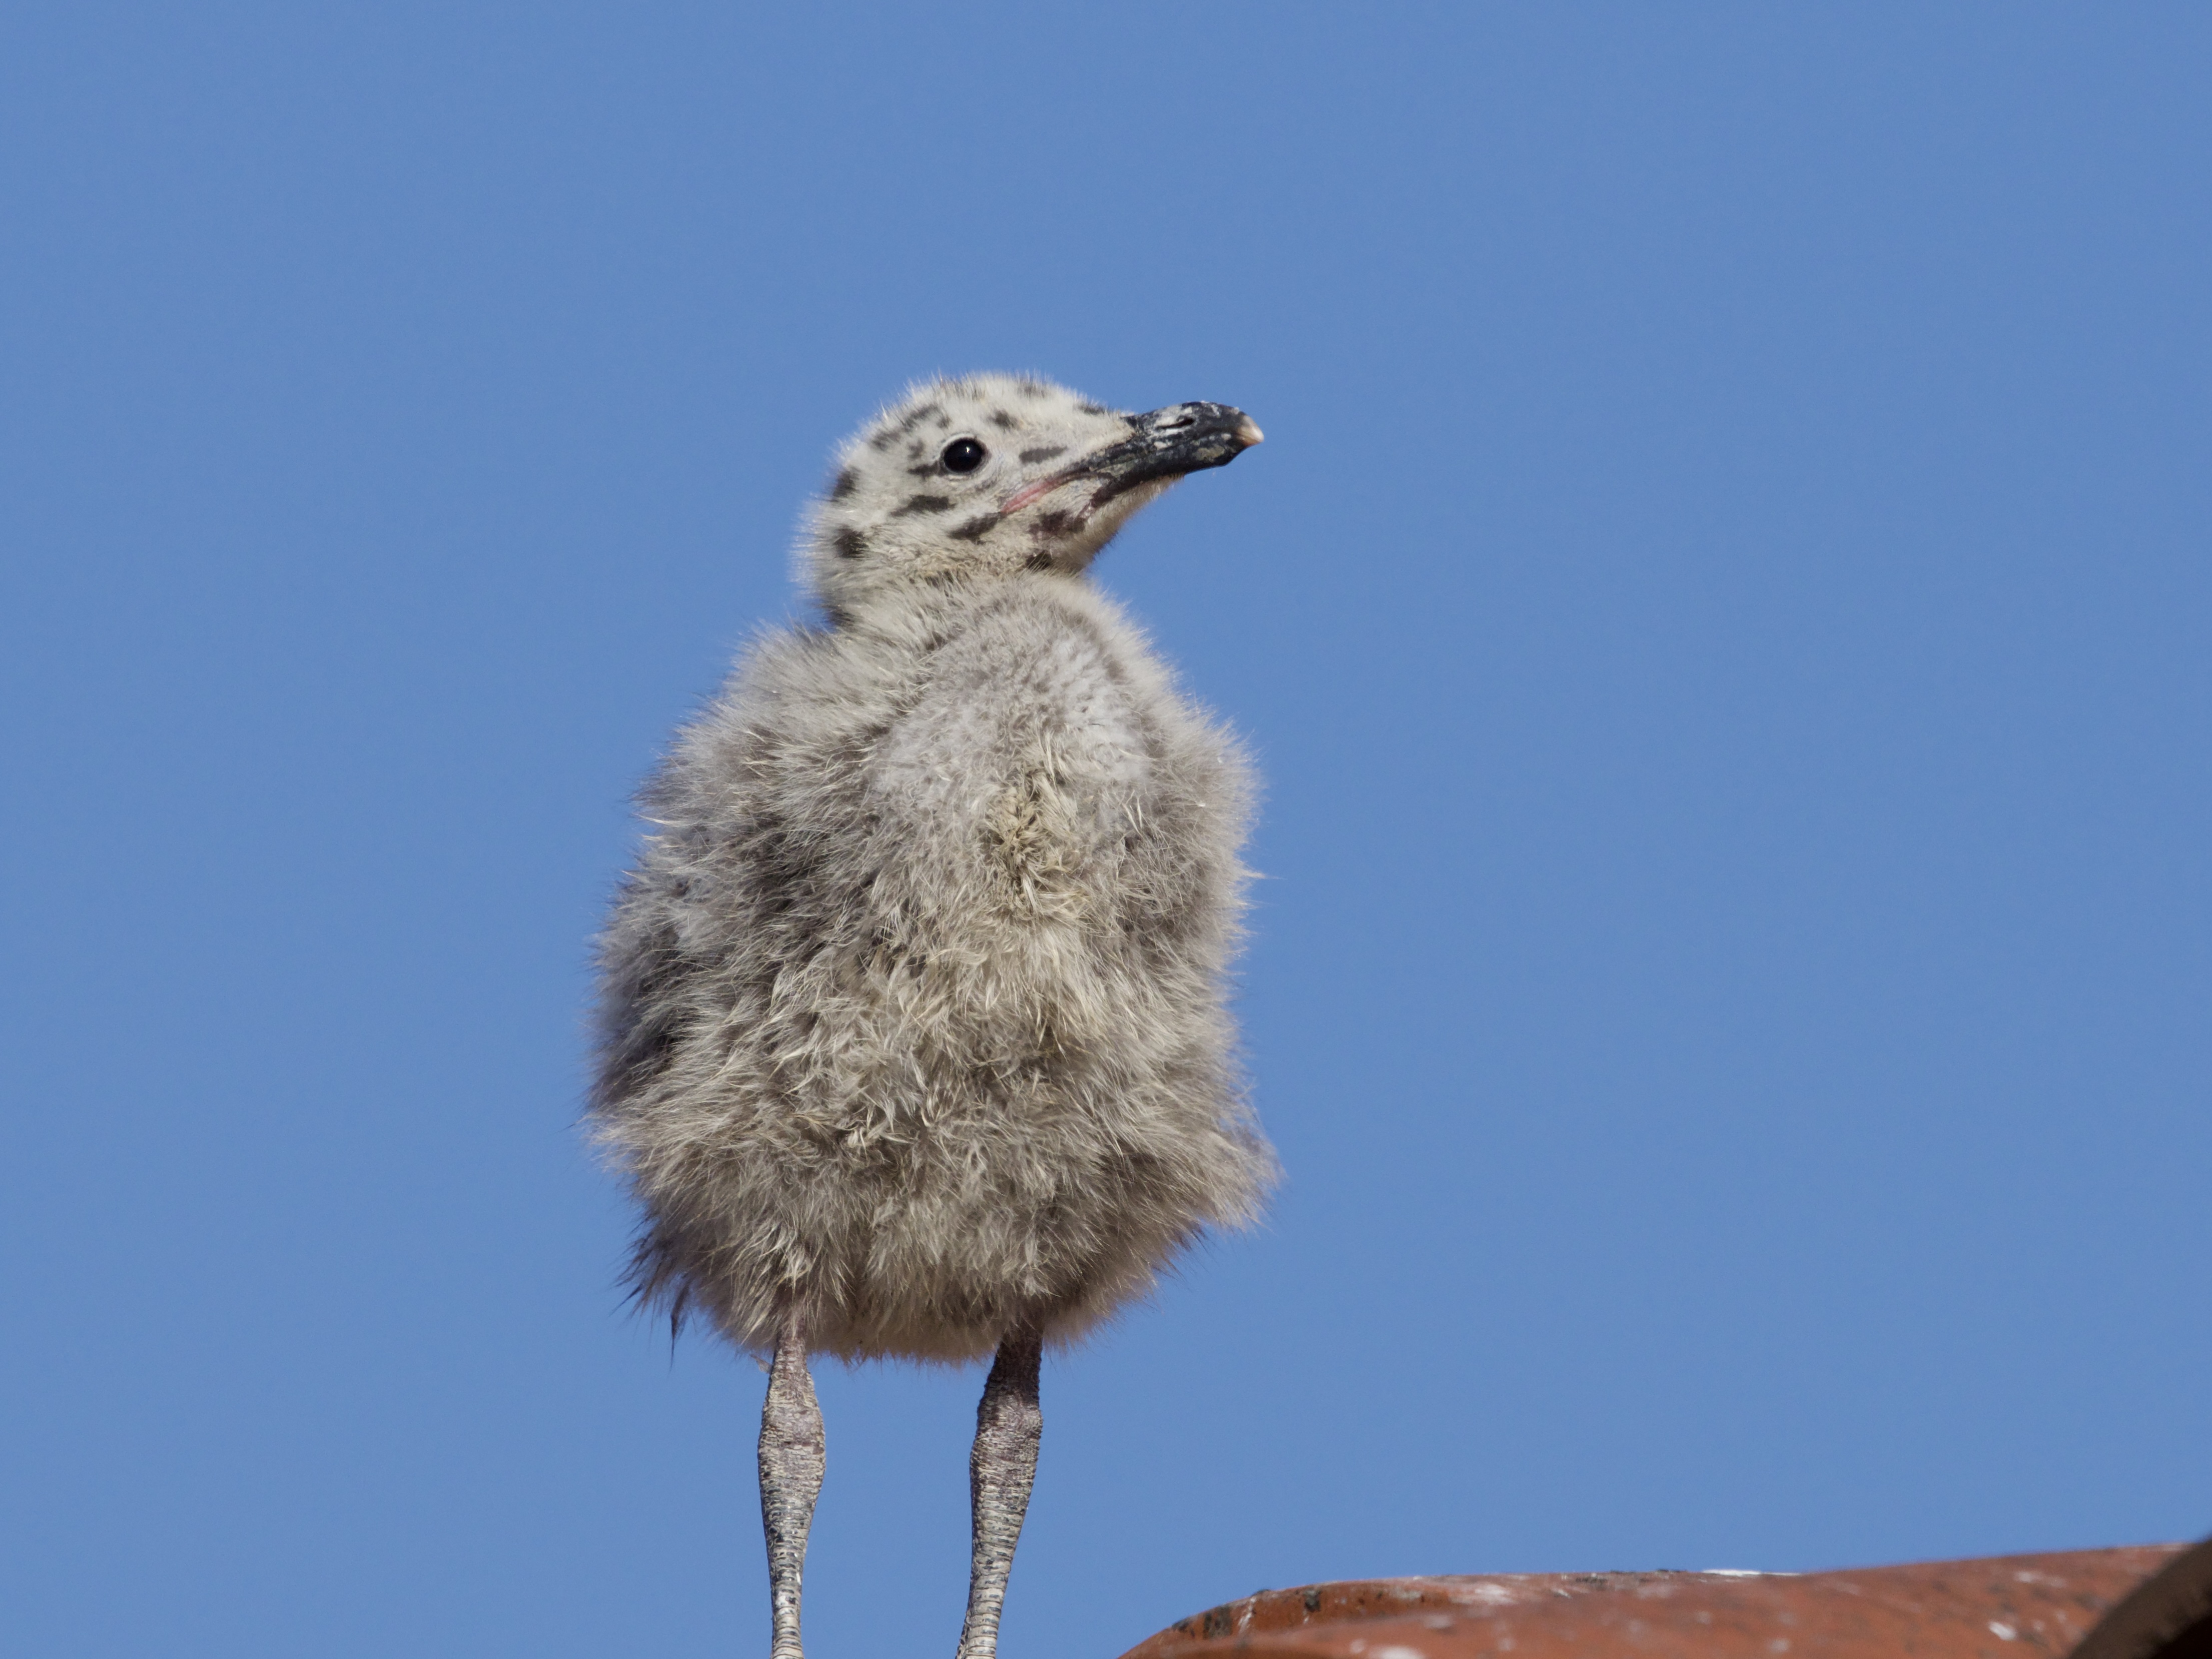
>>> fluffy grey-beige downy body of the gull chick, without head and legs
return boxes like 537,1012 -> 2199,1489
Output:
590,575 -> 1274,1360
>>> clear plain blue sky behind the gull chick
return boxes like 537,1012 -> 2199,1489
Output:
0,0 -> 2212,1659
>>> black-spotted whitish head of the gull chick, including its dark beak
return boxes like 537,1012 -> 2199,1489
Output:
801,374 -> 1261,617
